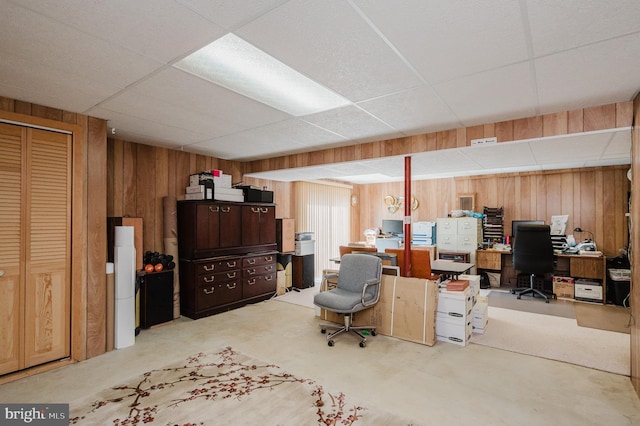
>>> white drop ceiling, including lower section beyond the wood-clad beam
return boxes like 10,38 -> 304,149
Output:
0,0 -> 640,183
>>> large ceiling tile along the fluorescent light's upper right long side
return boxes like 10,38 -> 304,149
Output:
235,0 -> 421,102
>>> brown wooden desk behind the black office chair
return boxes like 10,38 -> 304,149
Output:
476,250 -> 607,303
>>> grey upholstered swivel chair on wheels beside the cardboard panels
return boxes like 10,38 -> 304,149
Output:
313,254 -> 382,348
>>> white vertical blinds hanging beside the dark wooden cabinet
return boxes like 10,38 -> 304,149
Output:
295,182 -> 351,282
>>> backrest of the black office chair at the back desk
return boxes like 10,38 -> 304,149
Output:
513,224 -> 554,274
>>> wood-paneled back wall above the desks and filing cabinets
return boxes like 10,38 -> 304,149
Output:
352,165 -> 630,256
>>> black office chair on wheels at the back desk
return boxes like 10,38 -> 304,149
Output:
511,224 -> 556,303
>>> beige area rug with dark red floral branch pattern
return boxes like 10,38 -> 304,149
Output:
69,347 -> 415,426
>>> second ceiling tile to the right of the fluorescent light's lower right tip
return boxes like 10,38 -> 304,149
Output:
434,62 -> 537,126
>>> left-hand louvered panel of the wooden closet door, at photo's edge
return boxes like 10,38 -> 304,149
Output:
0,124 -> 26,374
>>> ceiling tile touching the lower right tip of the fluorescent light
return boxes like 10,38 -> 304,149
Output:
358,85 -> 461,135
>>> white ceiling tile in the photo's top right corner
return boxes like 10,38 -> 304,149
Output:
527,0 -> 640,56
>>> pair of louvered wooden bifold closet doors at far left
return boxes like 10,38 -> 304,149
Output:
0,124 -> 71,374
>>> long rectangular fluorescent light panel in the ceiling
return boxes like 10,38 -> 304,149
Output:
174,33 -> 351,116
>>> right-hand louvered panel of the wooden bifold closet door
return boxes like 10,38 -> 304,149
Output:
24,129 -> 71,367
